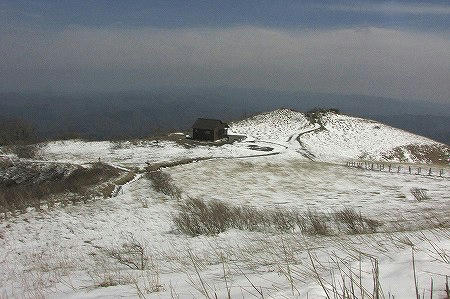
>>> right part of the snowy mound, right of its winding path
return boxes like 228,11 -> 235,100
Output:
302,113 -> 450,163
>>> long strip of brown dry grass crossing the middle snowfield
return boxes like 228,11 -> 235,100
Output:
173,198 -> 381,236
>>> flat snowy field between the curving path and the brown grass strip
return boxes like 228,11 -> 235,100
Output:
166,156 -> 450,218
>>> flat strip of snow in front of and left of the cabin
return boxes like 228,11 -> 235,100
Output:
40,140 -> 285,168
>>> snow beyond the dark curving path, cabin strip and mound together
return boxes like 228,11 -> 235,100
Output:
30,109 -> 450,171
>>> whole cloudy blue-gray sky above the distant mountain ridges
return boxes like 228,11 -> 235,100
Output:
0,0 -> 450,103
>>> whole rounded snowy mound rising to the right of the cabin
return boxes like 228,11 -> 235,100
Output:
231,109 -> 450,164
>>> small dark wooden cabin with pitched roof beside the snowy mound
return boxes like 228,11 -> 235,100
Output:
192,118 -> 228,141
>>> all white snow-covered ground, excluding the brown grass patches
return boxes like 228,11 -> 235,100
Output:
0,109 -> 450,298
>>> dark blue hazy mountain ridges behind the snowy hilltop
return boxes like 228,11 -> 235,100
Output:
0,87 -> 450,144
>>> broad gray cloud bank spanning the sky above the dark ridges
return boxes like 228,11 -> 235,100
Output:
0,27 -> 450,102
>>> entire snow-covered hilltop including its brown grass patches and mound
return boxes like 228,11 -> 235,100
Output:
0,109 -> 450,298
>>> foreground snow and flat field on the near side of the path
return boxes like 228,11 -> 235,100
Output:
0,162 -> 450,298
